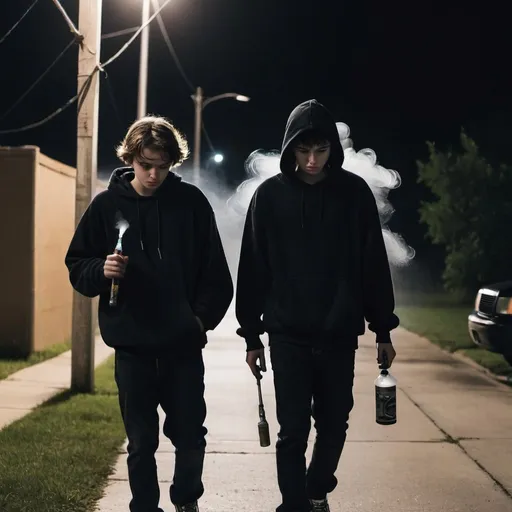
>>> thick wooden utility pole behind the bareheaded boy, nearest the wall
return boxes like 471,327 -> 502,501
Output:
71,0 -> 102,393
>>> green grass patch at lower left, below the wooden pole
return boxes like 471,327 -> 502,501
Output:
0,357 -> 125,512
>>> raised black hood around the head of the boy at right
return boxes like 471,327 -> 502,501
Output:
280,99 -> 344,176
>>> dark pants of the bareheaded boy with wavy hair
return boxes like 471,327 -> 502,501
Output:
115,350 -> 207,512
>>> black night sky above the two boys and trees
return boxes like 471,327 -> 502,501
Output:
0,0 -> 512,272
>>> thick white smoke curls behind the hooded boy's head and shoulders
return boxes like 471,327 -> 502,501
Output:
228,122 -> 415,267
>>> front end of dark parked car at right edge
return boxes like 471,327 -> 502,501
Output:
468,281 -> 512,365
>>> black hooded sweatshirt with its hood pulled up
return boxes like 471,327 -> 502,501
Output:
236,100 -> 399,350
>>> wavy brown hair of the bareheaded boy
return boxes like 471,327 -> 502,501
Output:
116,116 -> 189,167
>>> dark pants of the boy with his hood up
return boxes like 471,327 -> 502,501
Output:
270,339 -> 355,512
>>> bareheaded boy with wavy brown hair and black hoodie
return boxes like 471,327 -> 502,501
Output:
65,117 -> 233,512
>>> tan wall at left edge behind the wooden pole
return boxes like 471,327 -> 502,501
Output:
0,147 -> 105,356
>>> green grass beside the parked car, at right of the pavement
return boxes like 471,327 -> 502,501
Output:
396,302 -> 512,376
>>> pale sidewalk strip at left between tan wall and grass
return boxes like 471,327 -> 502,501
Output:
0,336 -> 113,430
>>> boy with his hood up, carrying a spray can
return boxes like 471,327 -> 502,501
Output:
236,100 -> 399,512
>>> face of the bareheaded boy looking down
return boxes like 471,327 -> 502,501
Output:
132,148 -> 171,196
